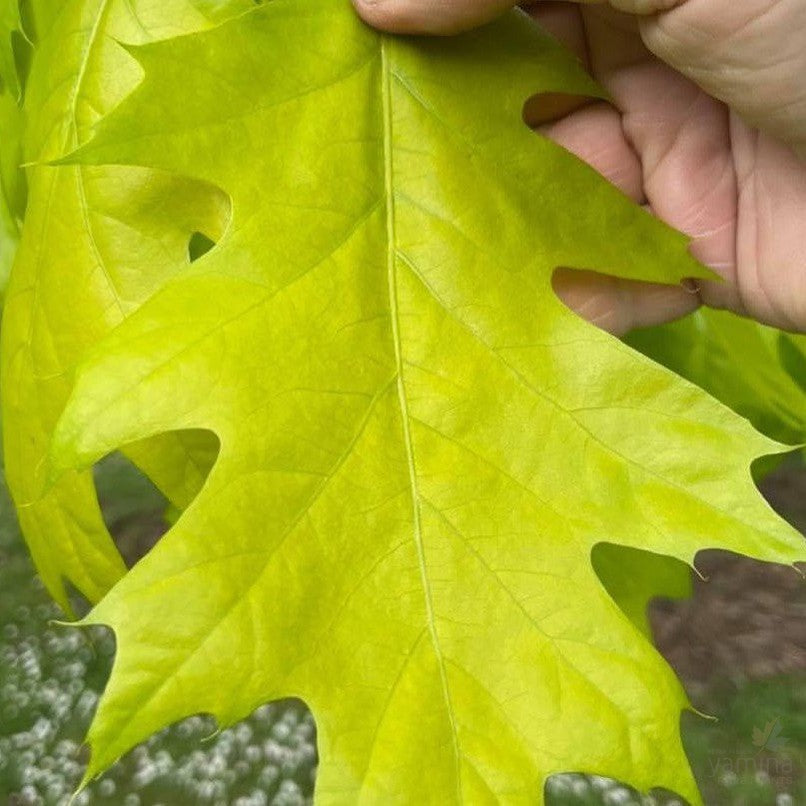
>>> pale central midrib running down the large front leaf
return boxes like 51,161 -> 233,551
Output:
380,35 -> 463,803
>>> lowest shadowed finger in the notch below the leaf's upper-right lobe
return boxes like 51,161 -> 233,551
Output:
554,269 -> 700,336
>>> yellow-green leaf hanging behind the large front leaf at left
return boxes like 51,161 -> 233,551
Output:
2,0 -> 252,609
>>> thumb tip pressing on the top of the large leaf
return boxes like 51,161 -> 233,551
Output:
353,0 -> 515,34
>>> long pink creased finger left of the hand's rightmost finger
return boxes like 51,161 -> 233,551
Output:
585,8 -> 741,300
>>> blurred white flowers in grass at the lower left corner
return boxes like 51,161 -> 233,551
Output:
0,588 -> 316,806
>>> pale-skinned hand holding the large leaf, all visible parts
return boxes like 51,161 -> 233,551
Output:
354,0 -> 806,336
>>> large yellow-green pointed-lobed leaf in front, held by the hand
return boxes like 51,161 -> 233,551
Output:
52,0 -> 804,804
